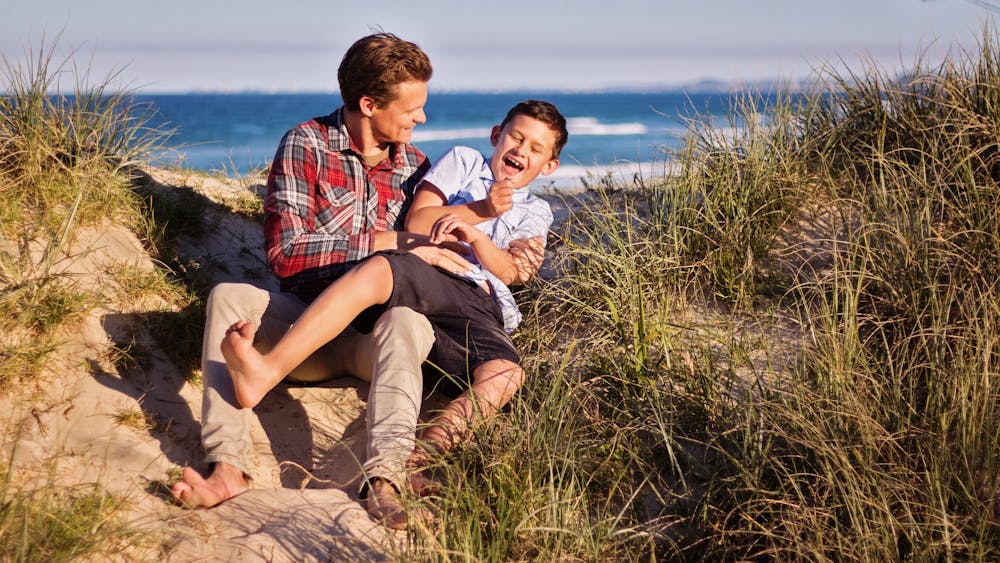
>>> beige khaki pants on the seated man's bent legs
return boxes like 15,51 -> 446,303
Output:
201,283 -> 434,492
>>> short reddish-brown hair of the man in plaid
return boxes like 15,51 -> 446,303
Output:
337,33 -> 433,111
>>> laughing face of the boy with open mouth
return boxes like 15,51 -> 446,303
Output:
490,115 -> 559,188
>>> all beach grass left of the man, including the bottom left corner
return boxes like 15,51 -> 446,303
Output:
0,43 -> 185,561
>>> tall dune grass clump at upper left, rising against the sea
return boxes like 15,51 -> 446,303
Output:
0,40 -> 169,389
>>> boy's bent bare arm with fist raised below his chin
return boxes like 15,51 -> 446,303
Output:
405,180 -> 514,233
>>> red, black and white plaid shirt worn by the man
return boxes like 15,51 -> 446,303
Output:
264,108 -> 429,298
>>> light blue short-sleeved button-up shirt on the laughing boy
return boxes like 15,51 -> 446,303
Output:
424,147 -> 552,332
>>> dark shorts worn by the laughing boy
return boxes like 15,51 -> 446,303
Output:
352,250 -> 521,397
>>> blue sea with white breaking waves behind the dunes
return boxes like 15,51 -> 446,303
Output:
138,91 -> 748,189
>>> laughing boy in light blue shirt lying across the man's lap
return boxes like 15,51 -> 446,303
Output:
222,100 -> 568,496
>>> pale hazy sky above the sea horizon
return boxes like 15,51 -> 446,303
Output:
0,0 -> 1000,93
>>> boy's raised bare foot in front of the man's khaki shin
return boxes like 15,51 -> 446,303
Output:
222,321 -> 281,409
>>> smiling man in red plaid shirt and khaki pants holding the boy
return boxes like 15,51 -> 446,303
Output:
173,33 -> 540,528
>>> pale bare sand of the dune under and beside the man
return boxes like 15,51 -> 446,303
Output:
0,170 -> 420,561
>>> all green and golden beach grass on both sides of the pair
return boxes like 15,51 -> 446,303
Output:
0,24 -> 1000,561
